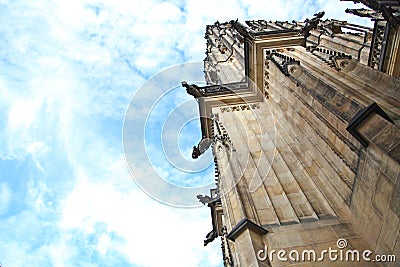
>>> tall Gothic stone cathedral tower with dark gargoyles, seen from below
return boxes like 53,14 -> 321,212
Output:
182,0 -> 400,267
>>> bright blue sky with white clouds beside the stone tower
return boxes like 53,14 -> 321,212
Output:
0,0 -> 368,267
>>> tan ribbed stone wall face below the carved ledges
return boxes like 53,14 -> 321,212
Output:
213,48 -> 400,266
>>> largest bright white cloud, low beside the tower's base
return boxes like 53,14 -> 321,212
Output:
60,161 -> 222,266
